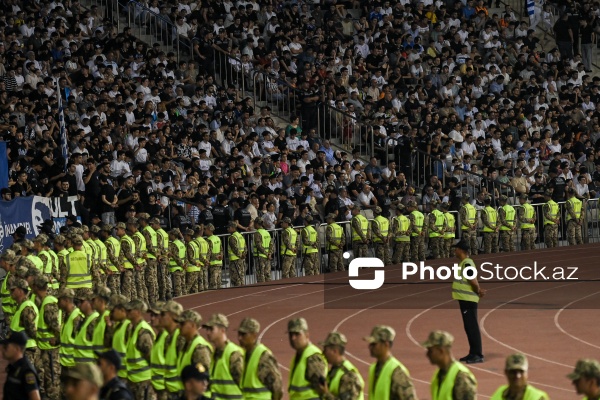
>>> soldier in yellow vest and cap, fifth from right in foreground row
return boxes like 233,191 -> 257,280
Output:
318,332 -> 365,400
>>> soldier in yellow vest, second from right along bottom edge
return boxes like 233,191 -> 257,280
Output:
491,353 -> 549,400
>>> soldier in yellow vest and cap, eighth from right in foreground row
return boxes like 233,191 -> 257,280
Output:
203,314 -> 244,400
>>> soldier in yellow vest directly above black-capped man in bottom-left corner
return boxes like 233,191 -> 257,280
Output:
9,278 -> 40,365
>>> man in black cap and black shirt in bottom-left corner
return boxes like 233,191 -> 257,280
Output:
0,332 -> 41,400
